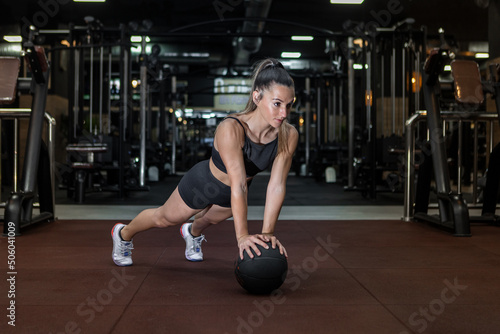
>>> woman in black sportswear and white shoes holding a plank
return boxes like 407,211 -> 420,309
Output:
111,59 -> 298,266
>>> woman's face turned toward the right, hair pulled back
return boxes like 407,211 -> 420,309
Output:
253,84 -> 295,128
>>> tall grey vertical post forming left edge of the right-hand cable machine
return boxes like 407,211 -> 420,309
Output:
347,37 -> 355,188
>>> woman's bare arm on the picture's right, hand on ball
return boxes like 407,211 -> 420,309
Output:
262,125 -> 299,255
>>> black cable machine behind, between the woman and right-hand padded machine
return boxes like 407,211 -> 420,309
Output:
336,18 -> 425,198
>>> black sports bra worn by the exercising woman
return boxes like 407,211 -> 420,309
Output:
212,117 -> 278,177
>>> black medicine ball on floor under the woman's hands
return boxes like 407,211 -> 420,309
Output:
234,242 -> 288,294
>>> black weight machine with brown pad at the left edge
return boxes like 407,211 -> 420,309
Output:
0,27 -> 55,235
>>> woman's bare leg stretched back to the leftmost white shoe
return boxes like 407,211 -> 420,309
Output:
120,188 -> 201,240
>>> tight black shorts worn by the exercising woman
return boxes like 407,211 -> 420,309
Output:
178,160 -> 231,209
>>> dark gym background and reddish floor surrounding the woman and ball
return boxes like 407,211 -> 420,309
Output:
0,0 -> 500,334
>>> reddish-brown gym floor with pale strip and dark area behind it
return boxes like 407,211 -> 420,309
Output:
0,176 -> 500,334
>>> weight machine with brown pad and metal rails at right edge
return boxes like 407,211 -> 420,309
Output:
405,49 -> 500,237
